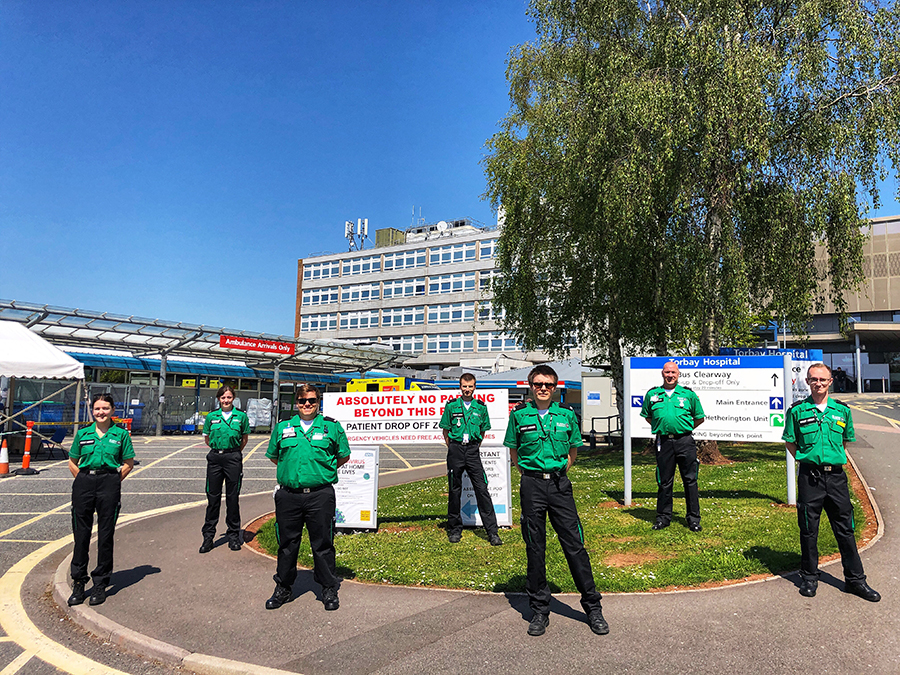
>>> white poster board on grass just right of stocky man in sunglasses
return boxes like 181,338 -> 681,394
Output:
334,445 -> 378,530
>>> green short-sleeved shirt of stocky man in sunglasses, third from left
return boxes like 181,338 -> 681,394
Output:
266,413 -> 350,488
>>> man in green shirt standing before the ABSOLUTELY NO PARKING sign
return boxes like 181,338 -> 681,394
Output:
440,373 -> 503,546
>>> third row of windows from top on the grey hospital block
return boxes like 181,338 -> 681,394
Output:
300,301 -> 502,331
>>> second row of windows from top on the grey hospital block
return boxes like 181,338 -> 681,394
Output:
301,270 -> 494,307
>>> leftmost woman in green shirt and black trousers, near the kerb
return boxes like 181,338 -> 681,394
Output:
68,394 -> 134,605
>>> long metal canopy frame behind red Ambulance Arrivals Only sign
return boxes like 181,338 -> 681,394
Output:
0,299 -> 405,373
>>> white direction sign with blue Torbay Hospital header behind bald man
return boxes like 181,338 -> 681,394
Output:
629,354 -> 791,443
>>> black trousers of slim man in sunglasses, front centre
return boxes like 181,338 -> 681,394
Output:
519,476 -> 601,614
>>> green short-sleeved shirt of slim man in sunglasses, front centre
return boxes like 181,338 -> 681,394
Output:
503,401 -> 584,472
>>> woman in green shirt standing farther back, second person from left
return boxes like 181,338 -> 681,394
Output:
200,384 -> 250,553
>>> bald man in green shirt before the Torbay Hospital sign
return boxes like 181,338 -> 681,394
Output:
641,361 -> 706,532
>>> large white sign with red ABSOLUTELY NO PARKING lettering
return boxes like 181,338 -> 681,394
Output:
323,389 -> 509,445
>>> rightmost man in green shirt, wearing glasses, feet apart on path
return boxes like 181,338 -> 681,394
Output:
781,363 -> 881,602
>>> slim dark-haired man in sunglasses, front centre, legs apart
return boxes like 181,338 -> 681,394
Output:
503,365 -> 609,635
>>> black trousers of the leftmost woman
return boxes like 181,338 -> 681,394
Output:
70,471 -> 122,586
